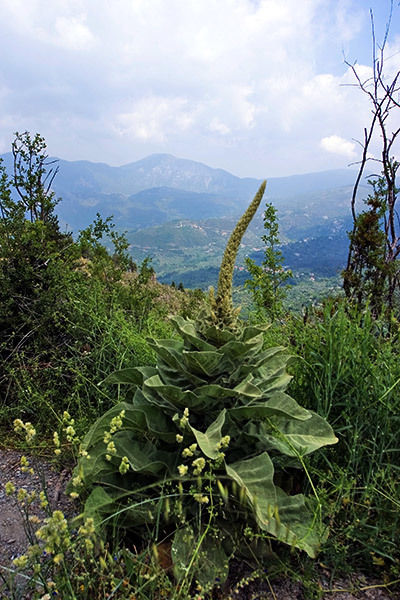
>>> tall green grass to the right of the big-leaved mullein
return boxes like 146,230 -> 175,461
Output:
280,302 -> 400,574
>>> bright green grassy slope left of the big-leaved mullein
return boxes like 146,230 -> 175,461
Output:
0,273 -> 201,438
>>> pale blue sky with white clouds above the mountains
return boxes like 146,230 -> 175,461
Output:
0,0 -> 400,178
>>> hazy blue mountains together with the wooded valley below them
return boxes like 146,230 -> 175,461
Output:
2,153 -> 367,287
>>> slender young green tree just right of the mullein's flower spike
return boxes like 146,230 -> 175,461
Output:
245,202 -> 293,320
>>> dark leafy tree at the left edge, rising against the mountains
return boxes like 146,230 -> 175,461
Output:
0,132 -> 73,344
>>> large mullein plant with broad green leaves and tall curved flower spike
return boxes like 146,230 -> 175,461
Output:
69,182 -> 337,581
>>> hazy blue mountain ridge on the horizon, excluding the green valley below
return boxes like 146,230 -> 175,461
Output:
2,153 -> 362,231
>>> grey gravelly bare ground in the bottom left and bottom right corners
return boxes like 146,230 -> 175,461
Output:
0,449 -> 400,600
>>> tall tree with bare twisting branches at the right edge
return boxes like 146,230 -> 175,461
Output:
343,1 -> 400,314
